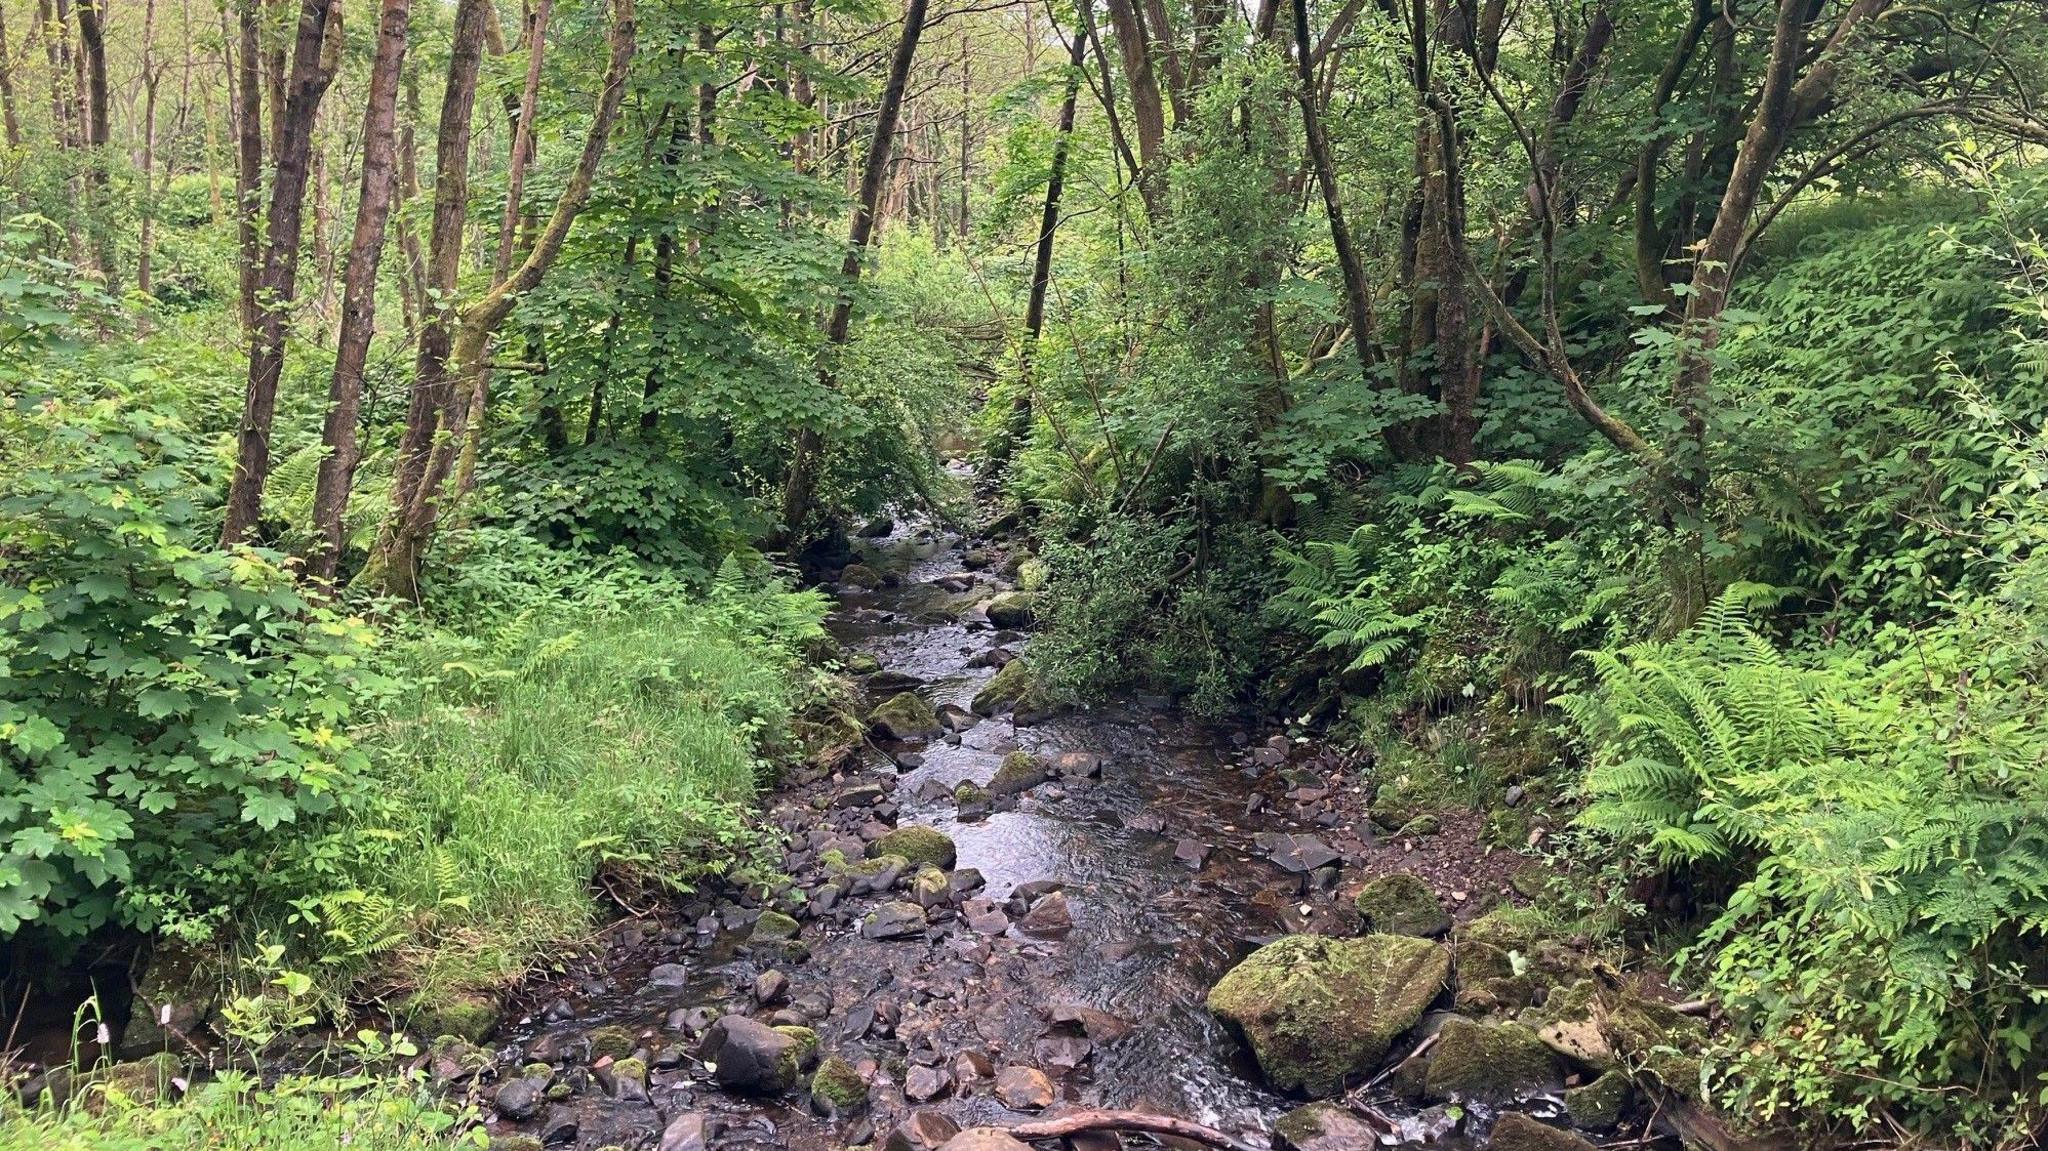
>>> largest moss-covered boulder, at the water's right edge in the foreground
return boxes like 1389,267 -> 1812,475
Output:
1208,936 -> 1450,1096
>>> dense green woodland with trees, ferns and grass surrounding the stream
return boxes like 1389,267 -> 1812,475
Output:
0,0 -> 2048,1147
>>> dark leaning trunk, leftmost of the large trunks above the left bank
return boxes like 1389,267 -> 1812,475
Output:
221,0 -> 342,547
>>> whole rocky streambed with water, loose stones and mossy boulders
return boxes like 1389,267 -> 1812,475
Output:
430,518 -> 1698,1151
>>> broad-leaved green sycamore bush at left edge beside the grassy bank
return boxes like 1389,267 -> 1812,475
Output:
0,401 -> 379,938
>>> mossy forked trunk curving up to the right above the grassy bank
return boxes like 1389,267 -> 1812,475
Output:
373,0 -> 635,602
